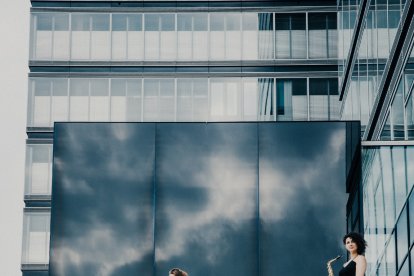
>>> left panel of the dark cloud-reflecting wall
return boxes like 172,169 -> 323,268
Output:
50,124 -> 154,276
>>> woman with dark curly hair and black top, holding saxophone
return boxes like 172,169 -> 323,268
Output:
339,232 -> 367,276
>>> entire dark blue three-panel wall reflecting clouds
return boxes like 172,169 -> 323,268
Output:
50,122 -> 350,276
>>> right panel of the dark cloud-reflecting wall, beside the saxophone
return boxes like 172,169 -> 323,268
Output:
259,123 -> 346,275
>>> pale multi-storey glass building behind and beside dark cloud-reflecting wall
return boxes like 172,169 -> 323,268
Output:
22,0 -> 414,275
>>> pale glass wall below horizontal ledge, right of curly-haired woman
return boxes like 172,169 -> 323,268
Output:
362,146 -> 414,275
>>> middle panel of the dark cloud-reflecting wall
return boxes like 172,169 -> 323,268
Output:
155,124 -> 258,276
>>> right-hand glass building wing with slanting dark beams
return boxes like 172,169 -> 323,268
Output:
338,0 -> 414,275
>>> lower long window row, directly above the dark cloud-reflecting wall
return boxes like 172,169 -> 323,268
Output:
28,77 -> 338,127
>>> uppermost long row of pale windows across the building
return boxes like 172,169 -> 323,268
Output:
30,12 -> 337,61
